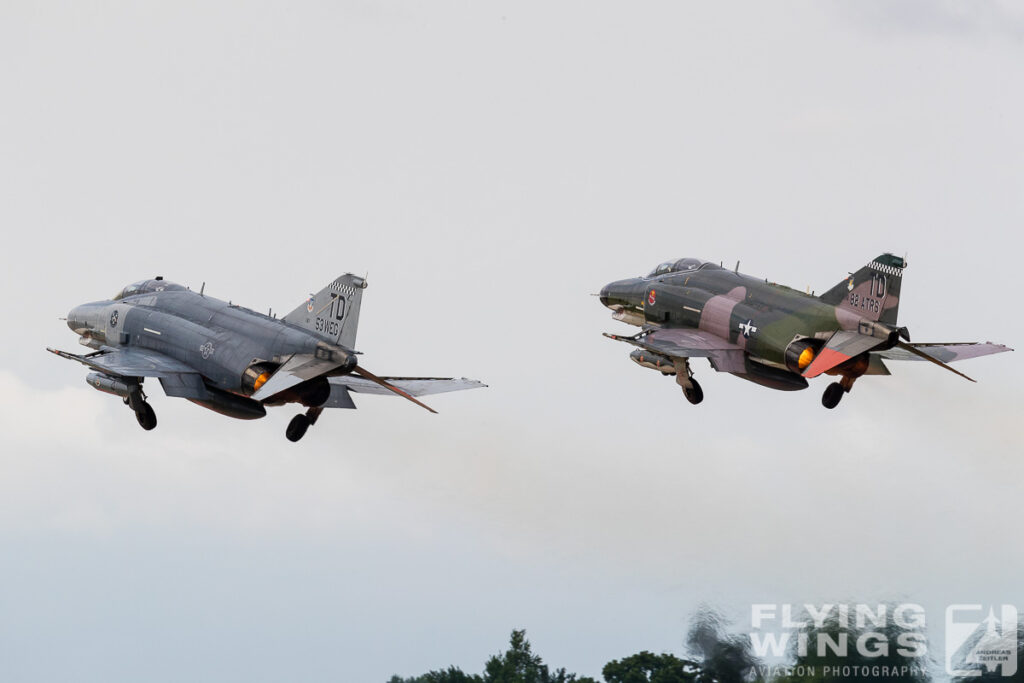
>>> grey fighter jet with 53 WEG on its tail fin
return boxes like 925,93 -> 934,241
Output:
48,273 -> 485,441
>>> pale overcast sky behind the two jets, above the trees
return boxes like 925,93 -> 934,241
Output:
0,0 -> 1024,683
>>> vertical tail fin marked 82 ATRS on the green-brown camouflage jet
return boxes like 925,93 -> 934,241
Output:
818,254 -> 906,325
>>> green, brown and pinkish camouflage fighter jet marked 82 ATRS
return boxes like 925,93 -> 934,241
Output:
599,254 -> 1013,409
